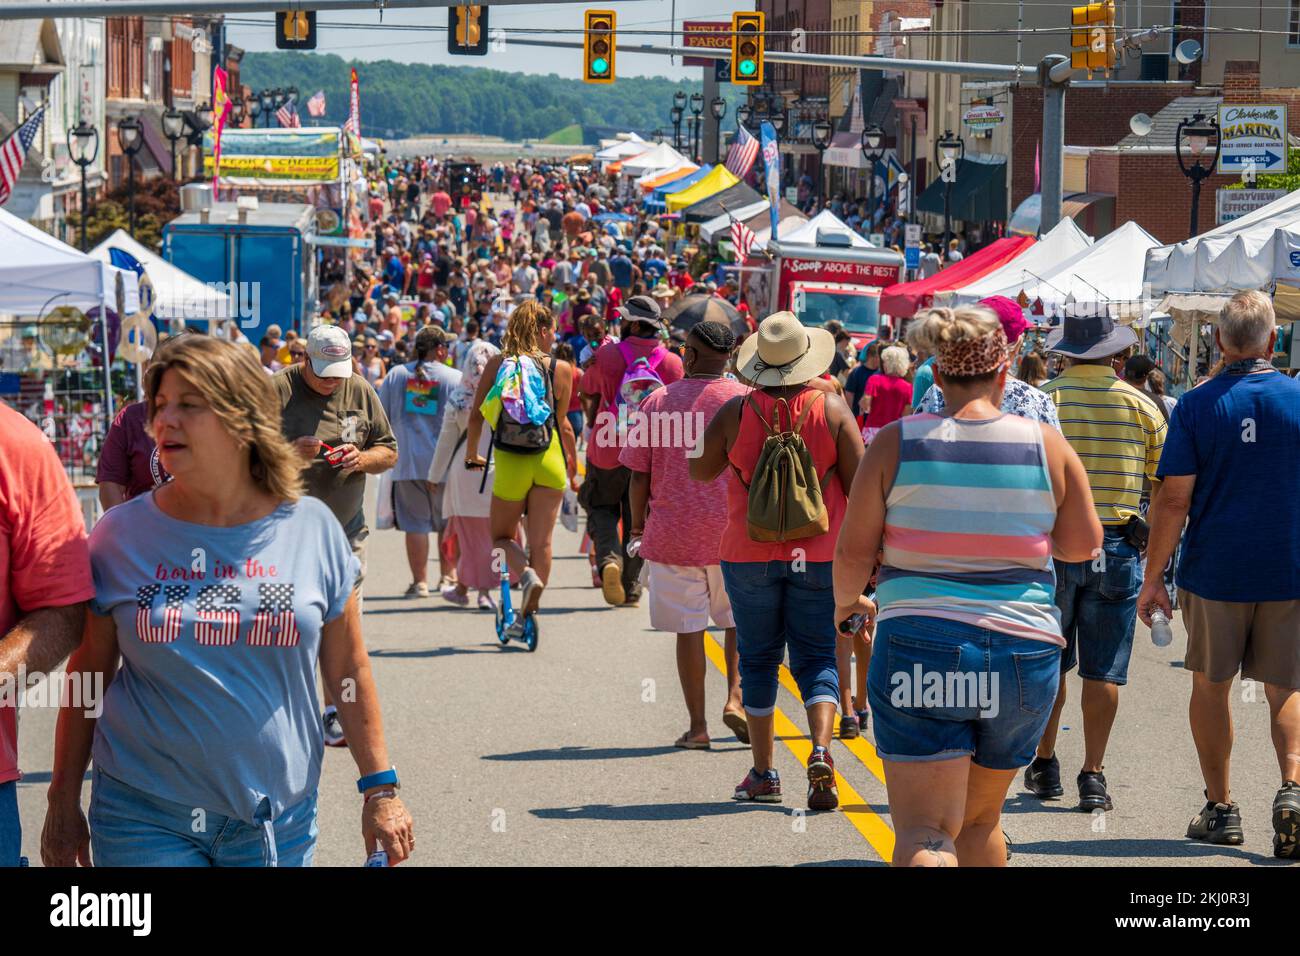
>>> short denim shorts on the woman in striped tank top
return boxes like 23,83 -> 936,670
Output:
868,615 -> 1061,770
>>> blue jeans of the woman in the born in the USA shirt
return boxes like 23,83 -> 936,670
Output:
87,767 -> 317,866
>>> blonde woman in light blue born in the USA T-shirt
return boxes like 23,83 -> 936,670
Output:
42,334 -> 415,866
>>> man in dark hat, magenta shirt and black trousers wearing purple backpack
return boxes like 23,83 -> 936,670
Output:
579,295 -> 683,606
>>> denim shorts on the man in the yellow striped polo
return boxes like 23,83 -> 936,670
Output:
1056,527 -> 1145,684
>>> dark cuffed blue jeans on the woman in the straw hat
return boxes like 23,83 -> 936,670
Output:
722,561 -> 840,717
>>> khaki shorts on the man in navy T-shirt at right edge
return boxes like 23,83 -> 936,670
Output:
1178,588 -> 1300,688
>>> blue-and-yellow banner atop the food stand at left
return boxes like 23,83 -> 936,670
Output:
203,127 -> 342,186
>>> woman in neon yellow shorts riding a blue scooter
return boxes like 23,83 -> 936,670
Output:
465,299 -> 577,624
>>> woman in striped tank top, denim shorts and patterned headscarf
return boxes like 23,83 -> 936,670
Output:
835,307 -> 1101,866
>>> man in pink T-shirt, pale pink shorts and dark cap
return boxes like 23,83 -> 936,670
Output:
619,321 -> 749,750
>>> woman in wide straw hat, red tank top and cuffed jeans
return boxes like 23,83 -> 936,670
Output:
690,312 -> 867,810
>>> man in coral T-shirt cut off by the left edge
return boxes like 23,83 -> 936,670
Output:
0,402 -> 95,866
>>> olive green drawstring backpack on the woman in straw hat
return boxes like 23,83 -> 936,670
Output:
732,392 -> 831,541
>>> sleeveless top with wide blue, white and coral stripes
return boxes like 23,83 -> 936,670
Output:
876,415 -> 1065,646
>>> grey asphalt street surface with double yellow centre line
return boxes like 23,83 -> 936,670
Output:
18,478 -> 1300,866
